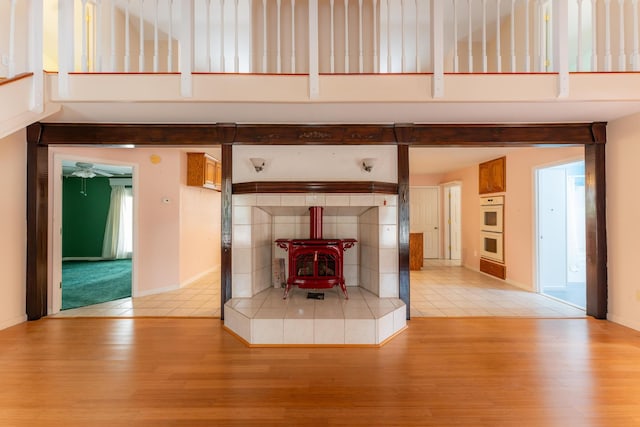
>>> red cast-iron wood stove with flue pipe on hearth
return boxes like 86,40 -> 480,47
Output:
276,206 -> 357,299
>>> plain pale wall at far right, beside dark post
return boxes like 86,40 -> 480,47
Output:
606,114 -> 640,330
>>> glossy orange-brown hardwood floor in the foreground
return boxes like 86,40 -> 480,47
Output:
0,318 -> 640,426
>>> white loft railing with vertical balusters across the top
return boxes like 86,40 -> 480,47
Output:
0,0 -> 640,97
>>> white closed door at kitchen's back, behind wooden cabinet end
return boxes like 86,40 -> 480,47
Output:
409,187 -> 440,258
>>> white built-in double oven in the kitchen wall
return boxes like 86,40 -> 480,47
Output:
480,196 -> 504,263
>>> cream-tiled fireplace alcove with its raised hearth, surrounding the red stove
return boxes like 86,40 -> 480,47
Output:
224,193 -> 406,345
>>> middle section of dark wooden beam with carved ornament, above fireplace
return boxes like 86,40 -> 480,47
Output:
234,124 -> 396,145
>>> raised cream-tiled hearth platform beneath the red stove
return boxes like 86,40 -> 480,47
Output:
224,286 -> 407,345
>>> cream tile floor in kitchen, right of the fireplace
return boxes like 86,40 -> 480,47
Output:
411,260 -> 585,317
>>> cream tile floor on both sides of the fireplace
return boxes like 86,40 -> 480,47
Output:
52,260 -> 585,317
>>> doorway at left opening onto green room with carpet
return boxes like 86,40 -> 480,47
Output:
50,158 -> 134,314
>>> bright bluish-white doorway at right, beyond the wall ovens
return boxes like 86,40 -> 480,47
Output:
536,161 -> 586,309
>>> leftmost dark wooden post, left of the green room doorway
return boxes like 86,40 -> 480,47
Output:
26,124 -> 49,320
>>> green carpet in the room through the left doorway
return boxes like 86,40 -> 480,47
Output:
62,259 -> 131,310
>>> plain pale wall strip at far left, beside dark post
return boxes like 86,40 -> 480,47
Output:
0,130 -> 27,329
